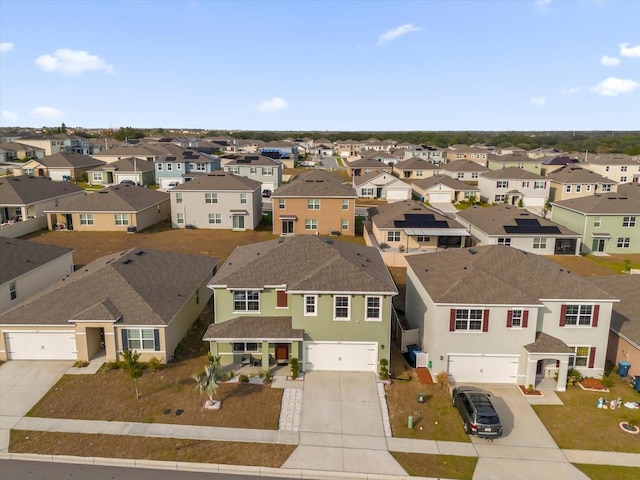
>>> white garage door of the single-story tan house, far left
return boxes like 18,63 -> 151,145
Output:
5,330 -> 78,360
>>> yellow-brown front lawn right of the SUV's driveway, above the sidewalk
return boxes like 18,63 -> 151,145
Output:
533,374 -> 640,453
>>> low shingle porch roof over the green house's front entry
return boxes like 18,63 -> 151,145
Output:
202,317 -> 304,342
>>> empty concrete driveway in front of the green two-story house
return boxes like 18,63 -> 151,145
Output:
283,372 -> 406,475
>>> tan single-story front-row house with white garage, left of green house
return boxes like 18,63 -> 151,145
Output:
0,248 -> 218,363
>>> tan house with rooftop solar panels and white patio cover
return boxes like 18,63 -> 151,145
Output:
365,200 -> 469,252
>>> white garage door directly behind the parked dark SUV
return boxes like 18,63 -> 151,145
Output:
449,355 -> 518,383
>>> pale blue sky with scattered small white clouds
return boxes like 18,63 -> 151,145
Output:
0,0 -> 640,130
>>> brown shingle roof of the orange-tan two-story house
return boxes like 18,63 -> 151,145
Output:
271,171 -> 358,198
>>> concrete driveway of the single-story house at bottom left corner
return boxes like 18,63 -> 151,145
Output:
0,360 -> 73,452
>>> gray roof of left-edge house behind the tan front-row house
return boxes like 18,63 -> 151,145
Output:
0,237 -> 73,284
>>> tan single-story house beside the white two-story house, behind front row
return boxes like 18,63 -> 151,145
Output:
44,185 -> 171,233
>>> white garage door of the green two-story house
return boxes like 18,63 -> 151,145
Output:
304,342 -> 378,372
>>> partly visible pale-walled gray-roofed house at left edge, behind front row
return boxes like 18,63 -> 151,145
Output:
0,238 -> 73,314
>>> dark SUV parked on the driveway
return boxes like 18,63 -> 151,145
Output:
452,386 -> 502,438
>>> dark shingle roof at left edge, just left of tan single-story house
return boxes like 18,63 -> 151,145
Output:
0,175 -> 82,205
